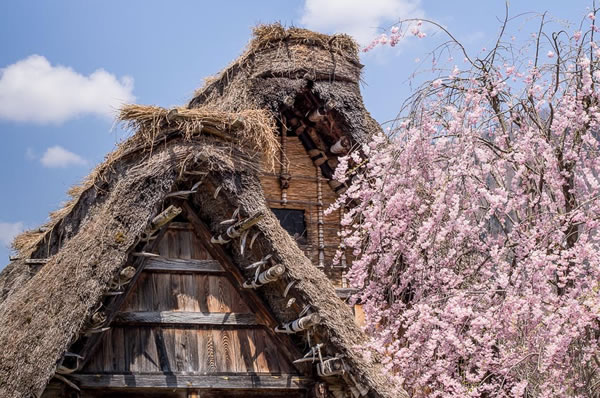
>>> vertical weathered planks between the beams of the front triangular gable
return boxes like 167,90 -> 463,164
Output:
82,223 -> 297,374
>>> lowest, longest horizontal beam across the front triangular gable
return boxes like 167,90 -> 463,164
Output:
69,373 -> 314,390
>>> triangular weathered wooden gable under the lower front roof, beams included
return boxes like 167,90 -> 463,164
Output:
44,220 -> 314,398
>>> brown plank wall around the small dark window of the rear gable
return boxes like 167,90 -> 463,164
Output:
261,136 -> 343,287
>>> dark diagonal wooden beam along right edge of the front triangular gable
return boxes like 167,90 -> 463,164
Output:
182,202 -> 303,374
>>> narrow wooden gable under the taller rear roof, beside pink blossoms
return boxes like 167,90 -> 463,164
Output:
261,93 -> 352,289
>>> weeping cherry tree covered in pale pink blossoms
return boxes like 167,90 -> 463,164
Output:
334,3 -> 600,397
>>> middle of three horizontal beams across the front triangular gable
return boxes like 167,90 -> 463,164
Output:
113,311 -> 258,326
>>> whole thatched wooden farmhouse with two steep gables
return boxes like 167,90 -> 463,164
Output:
0,24 -> 406,398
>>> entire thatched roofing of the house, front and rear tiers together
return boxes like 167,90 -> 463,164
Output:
0,26 -> 405,398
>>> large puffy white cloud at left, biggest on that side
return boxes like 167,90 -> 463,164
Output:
0,55 -> 135,124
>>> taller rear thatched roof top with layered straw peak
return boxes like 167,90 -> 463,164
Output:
189,24 -> 380,143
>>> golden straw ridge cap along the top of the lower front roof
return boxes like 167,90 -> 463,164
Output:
12,105 -> 279,257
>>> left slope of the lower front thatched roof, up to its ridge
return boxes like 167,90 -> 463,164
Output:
0,108 -> 272,397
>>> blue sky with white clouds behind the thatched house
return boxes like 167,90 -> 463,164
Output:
0,0 -> 590,268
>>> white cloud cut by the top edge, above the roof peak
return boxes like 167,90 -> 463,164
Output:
301,0 -> 425,45
